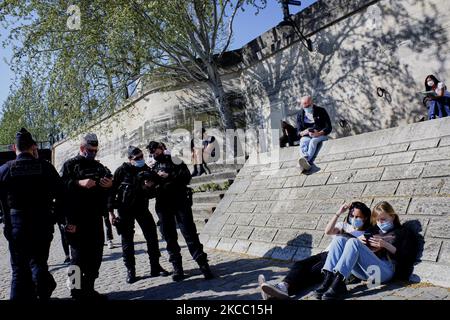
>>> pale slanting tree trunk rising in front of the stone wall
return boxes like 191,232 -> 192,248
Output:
207,65 -> 235,129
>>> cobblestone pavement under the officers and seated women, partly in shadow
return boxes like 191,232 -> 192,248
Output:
0,233 -> 450,300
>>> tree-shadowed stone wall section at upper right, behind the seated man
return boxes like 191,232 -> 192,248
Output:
241,0 -> 450,137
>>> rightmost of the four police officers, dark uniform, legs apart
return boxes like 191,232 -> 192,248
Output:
147,141 -> 214,281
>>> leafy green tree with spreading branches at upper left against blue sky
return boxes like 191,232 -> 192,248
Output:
0,0 -> 266,141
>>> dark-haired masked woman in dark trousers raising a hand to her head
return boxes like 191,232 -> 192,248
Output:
258,202 -> 371,299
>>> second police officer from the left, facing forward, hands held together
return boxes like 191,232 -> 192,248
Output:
62,133 -> 112,299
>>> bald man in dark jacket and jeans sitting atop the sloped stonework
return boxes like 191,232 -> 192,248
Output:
297,96 -> 332,170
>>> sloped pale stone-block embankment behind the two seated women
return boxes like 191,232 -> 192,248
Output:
201,118 -> 450,287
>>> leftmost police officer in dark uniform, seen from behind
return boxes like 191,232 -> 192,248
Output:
0,128 -> 62,300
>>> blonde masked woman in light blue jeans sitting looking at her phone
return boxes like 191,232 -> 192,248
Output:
315,201 -> 417,300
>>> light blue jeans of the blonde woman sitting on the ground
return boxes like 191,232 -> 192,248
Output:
323,236 -> 394,283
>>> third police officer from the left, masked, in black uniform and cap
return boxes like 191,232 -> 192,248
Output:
109,146 -> 169,283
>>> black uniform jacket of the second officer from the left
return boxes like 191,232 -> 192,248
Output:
61,155 -> 110,225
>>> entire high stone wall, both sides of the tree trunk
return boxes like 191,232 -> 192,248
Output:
54,0 -> 450,169
